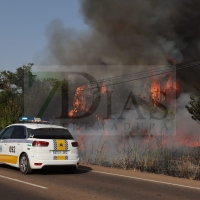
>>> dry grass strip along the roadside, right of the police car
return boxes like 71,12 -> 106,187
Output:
80,135 -> 200,180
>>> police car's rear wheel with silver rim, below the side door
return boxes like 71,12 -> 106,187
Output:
19,153 -> 32,174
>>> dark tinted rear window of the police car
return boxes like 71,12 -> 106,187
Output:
28,128 -> 73,140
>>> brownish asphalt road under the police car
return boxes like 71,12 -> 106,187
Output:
0,165 -> 200,200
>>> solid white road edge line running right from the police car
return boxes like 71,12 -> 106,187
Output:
78,168 -> 200,190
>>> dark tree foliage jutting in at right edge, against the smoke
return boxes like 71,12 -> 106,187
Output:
186,86 -> 200,122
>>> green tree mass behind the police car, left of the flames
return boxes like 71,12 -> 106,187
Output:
0,63 -> 68,131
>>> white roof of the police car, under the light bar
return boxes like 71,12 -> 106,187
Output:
8,123 -> 67,129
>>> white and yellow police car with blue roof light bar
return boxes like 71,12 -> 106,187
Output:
0,117 -> 79,174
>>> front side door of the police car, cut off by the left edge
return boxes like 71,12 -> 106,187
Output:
0,126 -> 15,163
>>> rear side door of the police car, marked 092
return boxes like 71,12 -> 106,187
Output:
7,125 -> 26,165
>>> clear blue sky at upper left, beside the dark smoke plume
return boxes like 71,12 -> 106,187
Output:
0,0 -> 87,71
